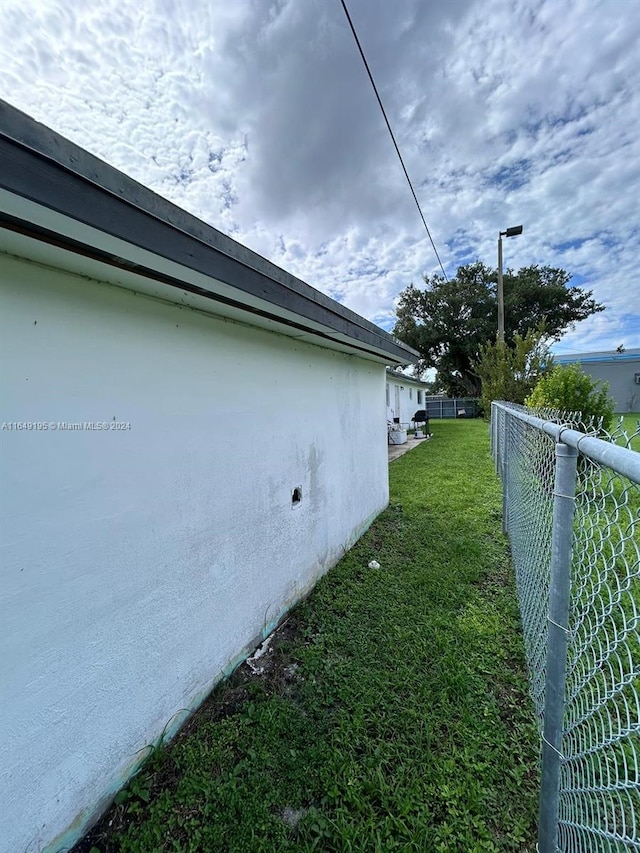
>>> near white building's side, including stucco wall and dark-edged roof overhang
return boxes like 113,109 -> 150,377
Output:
0,104 -> 415,853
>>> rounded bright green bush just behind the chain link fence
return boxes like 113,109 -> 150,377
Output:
525,364 -> 615,429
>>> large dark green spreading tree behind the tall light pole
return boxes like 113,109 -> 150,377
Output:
393,261 -> 604,397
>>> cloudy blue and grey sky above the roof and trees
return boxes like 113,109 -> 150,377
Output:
0,0 -> 640,354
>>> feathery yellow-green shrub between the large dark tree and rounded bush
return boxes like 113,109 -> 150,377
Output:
474,323 -> 553,414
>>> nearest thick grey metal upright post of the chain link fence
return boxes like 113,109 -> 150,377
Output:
538,444 -> 578,853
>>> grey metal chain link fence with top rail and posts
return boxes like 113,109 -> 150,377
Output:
491,403 -> 640,853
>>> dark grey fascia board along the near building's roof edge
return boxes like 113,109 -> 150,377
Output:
0,100 -> 419,364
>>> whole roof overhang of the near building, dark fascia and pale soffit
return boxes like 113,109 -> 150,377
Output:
0,101 -> 419,365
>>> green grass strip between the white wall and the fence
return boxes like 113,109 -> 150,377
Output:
77,420 -> 538,853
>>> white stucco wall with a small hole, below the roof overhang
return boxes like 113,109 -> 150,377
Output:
0,255 -> 388,853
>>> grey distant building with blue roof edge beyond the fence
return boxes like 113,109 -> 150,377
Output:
555,349 -> 640,413
